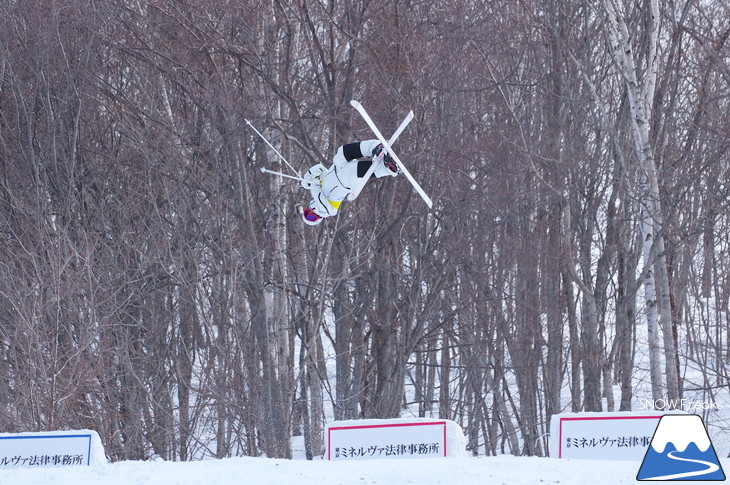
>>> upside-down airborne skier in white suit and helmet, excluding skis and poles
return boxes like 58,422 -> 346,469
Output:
301,140 -> 400,226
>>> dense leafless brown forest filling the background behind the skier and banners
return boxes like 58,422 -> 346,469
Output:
0,0 -> 730,460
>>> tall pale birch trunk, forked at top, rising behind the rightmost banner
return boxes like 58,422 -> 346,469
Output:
603,0 -> 679,400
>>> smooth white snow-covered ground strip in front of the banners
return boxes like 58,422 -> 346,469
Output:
0,456 -> 730,485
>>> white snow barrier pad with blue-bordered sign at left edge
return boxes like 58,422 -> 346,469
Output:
0,429 -> 107,469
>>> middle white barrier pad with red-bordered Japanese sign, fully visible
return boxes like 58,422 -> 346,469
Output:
326,418 -> 467,460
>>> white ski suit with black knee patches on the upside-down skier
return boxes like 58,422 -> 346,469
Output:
302,140 -> 398,217
